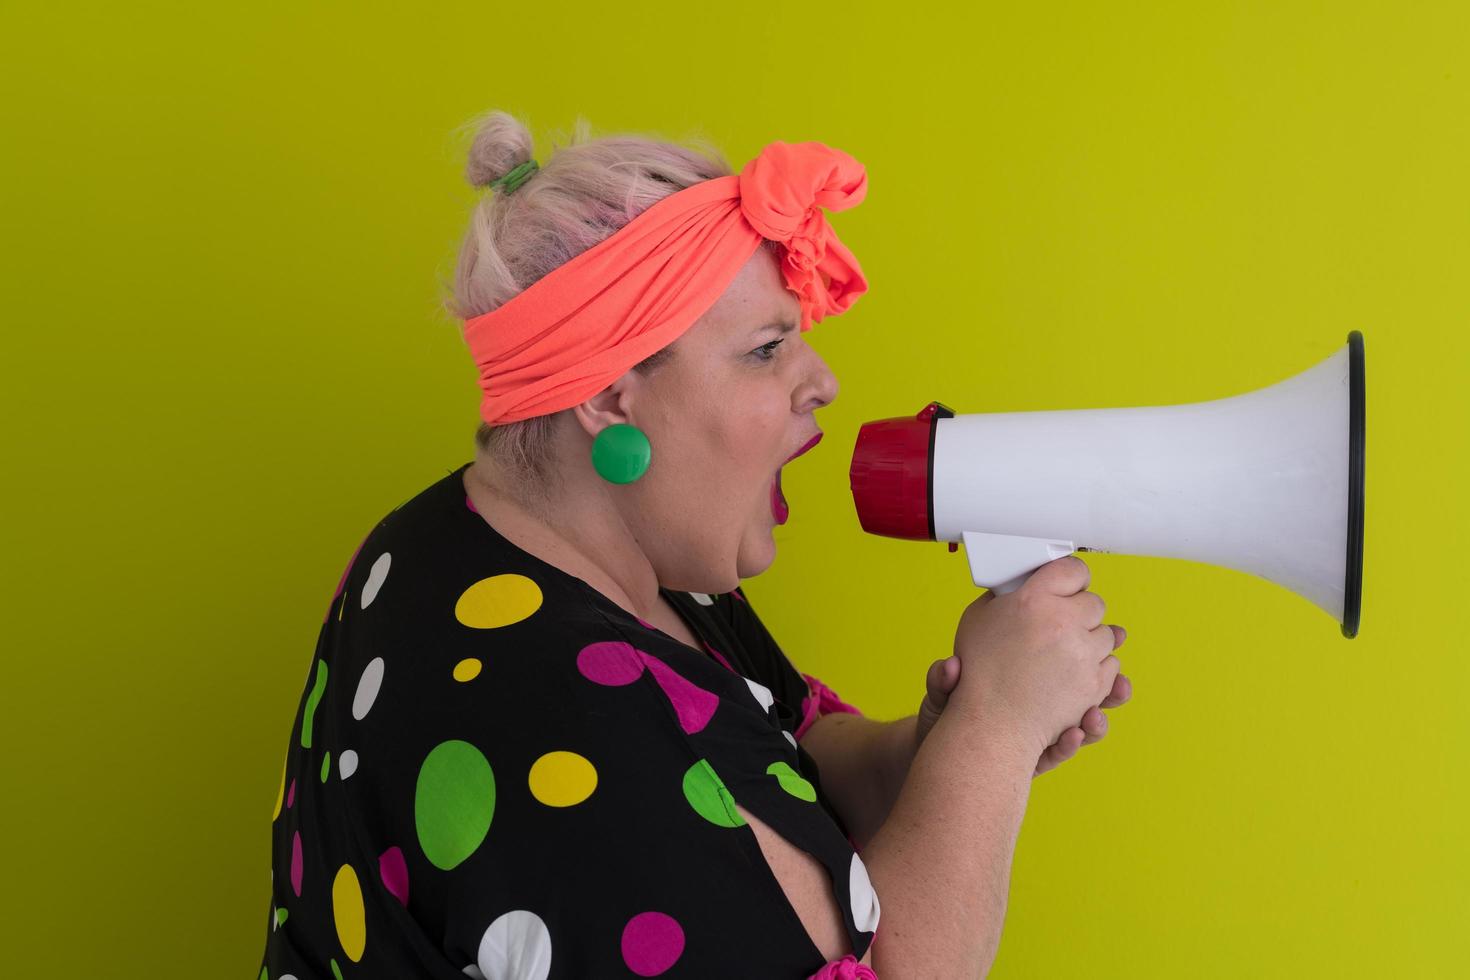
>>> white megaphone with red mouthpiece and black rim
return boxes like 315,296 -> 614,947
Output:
848,331 -> 1364,639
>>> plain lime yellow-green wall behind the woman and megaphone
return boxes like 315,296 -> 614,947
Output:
0,0 -> 1470,980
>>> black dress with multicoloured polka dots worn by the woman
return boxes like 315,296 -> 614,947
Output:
260,463 -> 879,980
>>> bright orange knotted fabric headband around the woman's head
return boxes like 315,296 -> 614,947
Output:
465,141 -> 867,425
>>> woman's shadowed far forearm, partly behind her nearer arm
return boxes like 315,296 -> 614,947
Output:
801,713 -> 919,851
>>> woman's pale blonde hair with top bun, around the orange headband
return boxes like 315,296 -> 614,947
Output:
444,110 -> 776,497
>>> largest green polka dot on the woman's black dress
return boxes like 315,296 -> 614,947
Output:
413,739 -> 495,871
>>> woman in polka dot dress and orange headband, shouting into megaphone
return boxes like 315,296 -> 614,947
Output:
262,113 -> 1126,980
